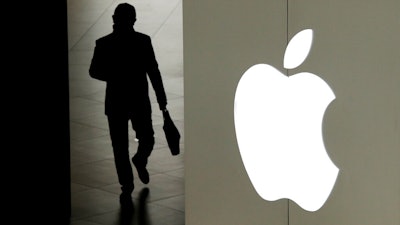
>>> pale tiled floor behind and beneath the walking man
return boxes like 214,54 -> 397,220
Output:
67,0 -> 185,225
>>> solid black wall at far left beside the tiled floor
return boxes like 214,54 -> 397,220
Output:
1,0 -> 71,224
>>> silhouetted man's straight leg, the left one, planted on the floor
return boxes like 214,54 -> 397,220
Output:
108,116 -> 134,196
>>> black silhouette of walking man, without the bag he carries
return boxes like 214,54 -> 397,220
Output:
89,3 -> 167,202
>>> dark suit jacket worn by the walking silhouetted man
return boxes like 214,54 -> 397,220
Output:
89,28 -> 167,115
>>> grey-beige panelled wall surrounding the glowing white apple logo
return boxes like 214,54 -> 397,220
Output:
183,0 -> 400,225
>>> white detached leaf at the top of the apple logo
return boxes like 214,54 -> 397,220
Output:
283,29 -> 313,69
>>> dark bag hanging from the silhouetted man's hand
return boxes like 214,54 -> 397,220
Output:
163,111 -> 181,155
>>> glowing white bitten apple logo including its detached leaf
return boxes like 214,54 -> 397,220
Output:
234,29 -> 339,211
